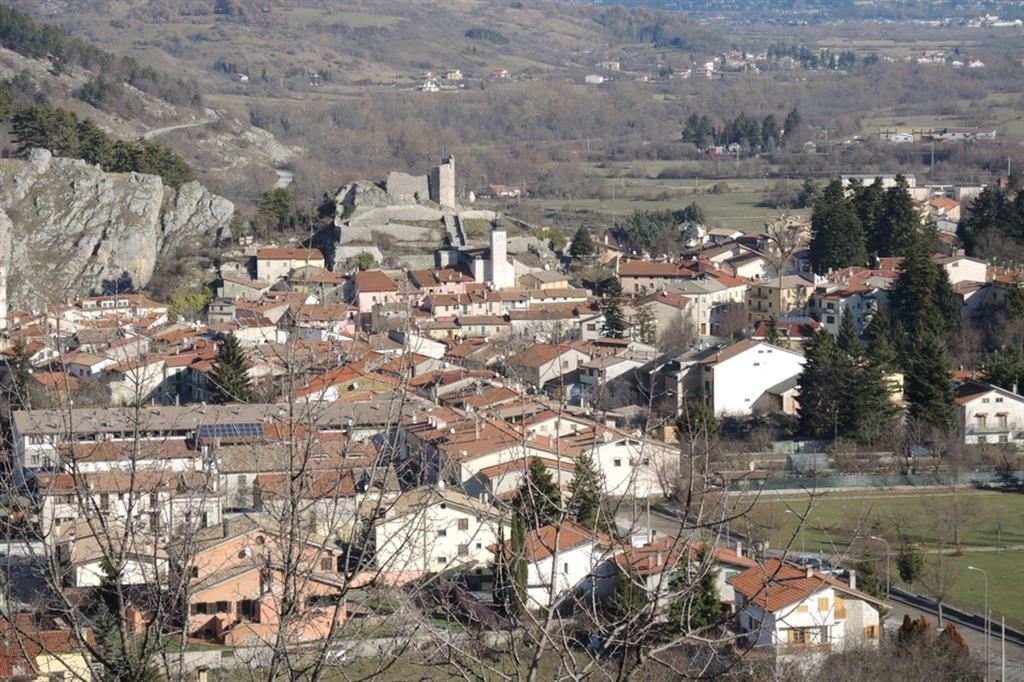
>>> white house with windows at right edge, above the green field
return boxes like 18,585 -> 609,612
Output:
956,379 -> 1024,445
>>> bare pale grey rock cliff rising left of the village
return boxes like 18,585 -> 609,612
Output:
0,150 -> 234,306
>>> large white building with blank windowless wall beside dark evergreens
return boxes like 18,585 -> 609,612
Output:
701,339 -> 804,415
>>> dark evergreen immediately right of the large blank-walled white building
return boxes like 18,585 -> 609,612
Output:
798,331 -> 842,438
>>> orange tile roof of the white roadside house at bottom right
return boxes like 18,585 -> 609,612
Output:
727,559 -> 882,611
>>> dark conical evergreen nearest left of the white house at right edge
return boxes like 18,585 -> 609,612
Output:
903,332 -> 956,433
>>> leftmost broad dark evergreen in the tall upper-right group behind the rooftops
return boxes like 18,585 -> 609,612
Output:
810,180 -> 867,273
